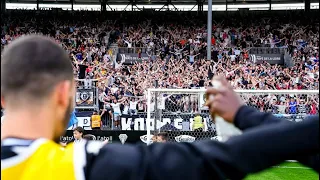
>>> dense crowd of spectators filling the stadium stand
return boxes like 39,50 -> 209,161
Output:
1,10 -> 319,128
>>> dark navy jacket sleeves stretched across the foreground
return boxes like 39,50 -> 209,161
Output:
89,106 -> 319,180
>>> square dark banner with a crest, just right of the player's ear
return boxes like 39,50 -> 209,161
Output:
76,88 -> 95,108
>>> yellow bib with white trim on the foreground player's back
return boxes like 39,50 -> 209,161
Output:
1,139 -> 93,180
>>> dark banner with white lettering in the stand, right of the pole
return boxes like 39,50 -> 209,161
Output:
250,54 -> 284,65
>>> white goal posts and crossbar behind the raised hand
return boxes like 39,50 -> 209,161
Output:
146,88 -> 319,145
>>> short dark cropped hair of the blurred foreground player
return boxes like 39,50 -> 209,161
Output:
1,35 -> 73,100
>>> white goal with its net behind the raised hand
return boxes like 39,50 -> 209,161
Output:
146,89 -> 319,144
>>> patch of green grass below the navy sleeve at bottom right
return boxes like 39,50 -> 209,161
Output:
245,162 -> 319,180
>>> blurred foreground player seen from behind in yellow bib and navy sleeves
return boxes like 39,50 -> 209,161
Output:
1,35 -> 319,180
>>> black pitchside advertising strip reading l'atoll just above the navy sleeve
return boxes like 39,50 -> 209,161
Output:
60,130 -> 216,144
